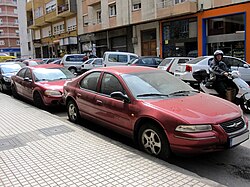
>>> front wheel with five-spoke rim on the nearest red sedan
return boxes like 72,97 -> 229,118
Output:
138,123 -> 171,160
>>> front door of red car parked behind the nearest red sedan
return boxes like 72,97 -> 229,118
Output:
22,68 -> 34,100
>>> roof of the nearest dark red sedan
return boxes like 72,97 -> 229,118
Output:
90,66 -> 161,74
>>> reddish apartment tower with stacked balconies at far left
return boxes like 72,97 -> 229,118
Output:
0,0 -> 20,56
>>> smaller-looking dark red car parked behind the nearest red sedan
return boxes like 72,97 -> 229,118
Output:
11,64 -> 74,108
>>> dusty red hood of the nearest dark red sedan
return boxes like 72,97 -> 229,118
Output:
144,93 -> 241,124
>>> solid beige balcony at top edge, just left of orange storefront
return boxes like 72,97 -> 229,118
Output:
156,0 -> 197,18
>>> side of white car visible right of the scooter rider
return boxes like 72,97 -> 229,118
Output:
223,57 -> 250,82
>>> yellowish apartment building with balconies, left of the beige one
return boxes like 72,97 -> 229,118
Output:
26,0 -> 78,58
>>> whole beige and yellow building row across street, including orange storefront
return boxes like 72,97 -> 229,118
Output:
26,0 -> 250,61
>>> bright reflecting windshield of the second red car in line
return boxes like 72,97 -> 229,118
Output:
33,68 -> 74,82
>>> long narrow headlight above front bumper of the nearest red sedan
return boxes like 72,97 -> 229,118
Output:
175,125 -> 212,132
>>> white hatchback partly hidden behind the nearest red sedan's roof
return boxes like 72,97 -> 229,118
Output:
158,57 -> 194,74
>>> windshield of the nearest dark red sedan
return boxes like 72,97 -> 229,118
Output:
121,71 -> 197,98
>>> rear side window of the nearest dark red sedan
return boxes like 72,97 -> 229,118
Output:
80,72 -> 101,91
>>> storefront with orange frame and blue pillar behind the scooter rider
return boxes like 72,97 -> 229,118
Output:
198,3 -> 250,62
